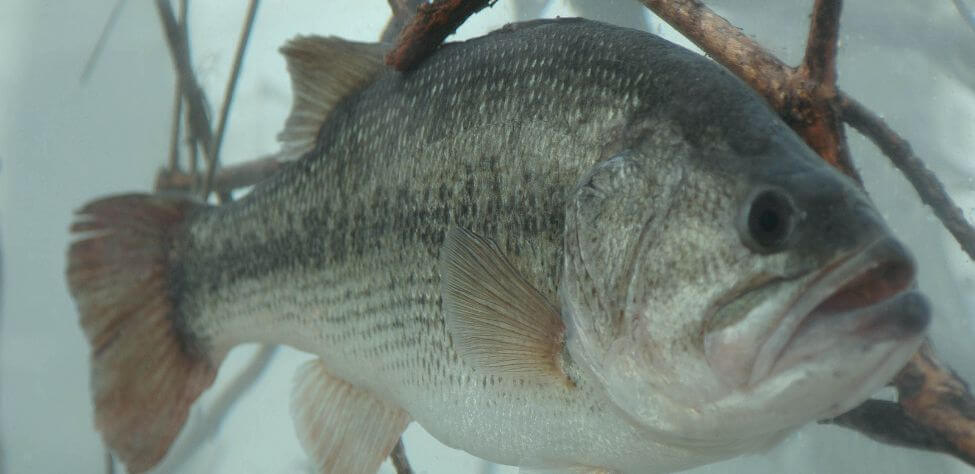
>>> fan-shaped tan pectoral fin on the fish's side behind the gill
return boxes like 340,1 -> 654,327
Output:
440,227 -> 571,384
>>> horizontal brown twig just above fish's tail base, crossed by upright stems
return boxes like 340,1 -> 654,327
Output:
155,155 -> 282,193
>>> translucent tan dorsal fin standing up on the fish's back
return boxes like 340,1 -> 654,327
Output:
278,36 -> 388,160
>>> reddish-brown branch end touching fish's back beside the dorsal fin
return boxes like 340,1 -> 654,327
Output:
386,0 -> 493,71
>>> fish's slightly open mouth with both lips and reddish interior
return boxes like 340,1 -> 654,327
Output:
748,237 -> 930,386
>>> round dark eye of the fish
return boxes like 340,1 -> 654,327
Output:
743,189 -> 796,253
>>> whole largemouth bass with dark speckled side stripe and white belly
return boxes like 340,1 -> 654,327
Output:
67,19 -> 930,473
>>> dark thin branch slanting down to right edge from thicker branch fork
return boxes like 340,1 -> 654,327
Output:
840,93 -> 975,260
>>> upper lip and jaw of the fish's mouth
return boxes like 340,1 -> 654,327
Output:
748,236 -> 927,386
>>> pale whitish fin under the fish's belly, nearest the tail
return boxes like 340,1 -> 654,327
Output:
291,360 -> 410,474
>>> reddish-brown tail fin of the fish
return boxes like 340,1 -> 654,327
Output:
67,194 -> 219,472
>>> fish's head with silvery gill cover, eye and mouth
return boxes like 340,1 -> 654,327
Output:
560,127 -> 929,446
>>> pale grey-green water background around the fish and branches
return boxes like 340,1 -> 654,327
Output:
0,0 -> 975,474
